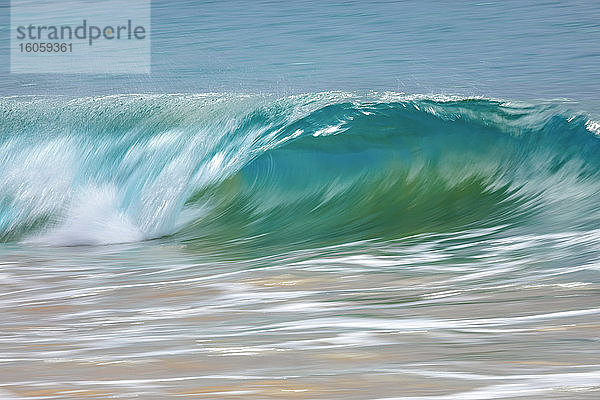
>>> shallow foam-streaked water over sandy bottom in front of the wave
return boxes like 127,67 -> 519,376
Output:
0,232 -> 600,399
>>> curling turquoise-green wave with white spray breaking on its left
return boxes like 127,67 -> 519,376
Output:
0,93 -> 600,247
